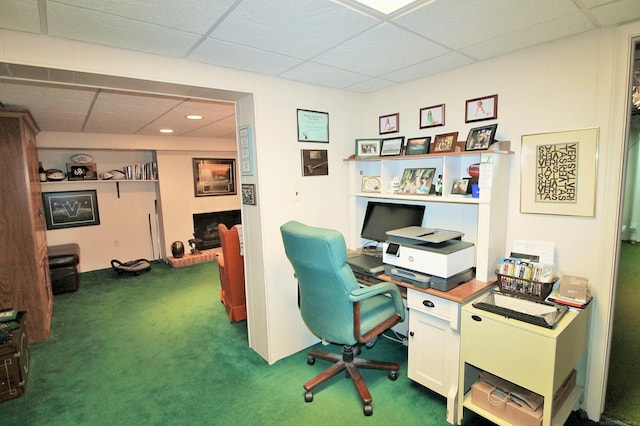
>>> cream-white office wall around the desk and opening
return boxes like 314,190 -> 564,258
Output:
0,24 -> 640,419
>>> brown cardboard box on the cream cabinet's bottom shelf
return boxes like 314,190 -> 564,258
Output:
471,380 -> 543,426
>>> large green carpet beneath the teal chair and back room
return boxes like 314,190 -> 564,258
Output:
0,262 -> 608,426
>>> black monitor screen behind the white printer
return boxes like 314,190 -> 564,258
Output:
360,201 -> 424,242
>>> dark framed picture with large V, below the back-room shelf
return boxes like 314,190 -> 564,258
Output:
42,189 -> 100,230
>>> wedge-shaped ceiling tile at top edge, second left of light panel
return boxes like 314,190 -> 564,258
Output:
48,0 -> 235,35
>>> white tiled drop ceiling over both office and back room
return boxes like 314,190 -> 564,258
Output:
0,0 -> 640,137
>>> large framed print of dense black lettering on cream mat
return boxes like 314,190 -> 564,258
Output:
520,127 -> 598,217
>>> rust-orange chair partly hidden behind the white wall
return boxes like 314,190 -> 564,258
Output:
216,223 -> 247,322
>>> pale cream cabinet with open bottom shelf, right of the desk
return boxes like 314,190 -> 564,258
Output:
456,303 -> 590,425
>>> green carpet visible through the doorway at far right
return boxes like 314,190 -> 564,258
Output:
604,242 -> 640,425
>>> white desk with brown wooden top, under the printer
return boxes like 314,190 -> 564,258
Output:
365,274 -> 494,424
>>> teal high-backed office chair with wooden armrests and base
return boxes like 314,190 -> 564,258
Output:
280,221 -> 404,416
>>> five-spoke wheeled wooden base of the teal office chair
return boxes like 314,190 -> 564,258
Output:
304,345 -> 400,416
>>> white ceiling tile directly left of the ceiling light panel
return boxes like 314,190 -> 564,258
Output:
211,0 -> 377,59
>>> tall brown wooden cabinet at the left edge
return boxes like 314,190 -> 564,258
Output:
0,110 -> 53,342
